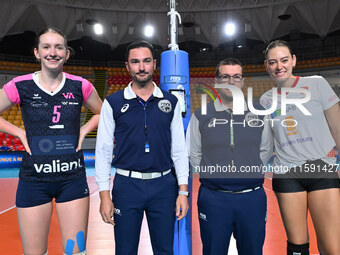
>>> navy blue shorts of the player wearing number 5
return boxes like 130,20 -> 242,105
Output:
15,177 -> 90,207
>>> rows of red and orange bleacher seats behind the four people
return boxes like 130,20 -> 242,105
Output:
0,57 -> 340,150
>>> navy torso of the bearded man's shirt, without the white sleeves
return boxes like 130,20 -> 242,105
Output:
106,87 -> 178,172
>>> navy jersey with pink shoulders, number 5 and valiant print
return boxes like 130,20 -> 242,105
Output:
4,73 -> 93,182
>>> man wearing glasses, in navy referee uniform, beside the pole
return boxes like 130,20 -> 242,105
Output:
187,58 -> 272,255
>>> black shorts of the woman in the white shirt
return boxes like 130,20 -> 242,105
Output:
272,159 -> 340,193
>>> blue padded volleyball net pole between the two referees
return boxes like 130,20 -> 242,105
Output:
160,0 -> 192,255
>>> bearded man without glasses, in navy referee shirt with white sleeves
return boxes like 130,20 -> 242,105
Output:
96,41 -> 189,255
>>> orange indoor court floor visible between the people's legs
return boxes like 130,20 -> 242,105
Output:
0,168 -> 318,255
